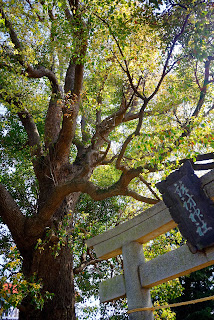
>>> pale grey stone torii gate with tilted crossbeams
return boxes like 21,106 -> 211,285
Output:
87,170 -> 214,320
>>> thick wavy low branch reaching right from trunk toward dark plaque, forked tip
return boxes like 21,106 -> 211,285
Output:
25,167 -> 158,237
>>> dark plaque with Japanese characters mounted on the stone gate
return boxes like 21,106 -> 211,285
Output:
156,161 -> 214,253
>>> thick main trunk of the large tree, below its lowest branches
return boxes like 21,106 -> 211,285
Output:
19,194 -> 79,320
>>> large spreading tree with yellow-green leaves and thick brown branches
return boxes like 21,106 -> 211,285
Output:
0,0 -> 214,320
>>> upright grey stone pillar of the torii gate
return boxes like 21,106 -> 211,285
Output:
122,241 -> 154,320
